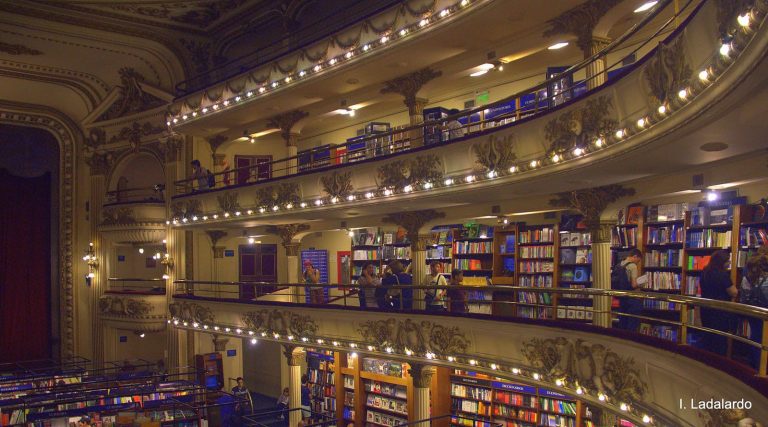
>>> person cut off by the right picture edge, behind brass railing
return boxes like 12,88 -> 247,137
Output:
739,254 -> 768,369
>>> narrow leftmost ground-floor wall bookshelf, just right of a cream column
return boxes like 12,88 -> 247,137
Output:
307,350 -> 337,417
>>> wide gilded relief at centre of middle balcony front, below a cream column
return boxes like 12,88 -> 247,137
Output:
376,154 -> 443,191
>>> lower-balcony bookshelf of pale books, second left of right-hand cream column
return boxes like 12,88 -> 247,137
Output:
517,225 -> 559,319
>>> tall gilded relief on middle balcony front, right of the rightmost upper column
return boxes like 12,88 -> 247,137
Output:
643,37 -> 692,104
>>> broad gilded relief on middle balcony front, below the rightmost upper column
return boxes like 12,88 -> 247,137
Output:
544,96 -> 618,156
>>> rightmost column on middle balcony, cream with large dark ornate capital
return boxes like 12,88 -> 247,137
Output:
544,0 -> 620,89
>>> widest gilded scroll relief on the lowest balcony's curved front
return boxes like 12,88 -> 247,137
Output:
520,337 -> 648,402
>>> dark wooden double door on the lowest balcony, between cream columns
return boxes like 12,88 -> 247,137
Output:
238,243 -> 277,299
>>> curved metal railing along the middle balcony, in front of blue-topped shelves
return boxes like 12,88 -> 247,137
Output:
174,0 -> 705,197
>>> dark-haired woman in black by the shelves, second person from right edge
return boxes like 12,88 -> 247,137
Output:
701,250 -> 739,355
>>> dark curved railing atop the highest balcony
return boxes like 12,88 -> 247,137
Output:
176,0 -> 403,97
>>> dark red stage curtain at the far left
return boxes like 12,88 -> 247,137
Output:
0,170 -> 51,362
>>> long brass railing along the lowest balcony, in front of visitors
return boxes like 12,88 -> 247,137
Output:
173,280 -> 768,377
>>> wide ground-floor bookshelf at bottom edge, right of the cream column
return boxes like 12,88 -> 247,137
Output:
450,370 -> 594,427
